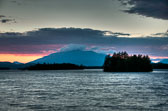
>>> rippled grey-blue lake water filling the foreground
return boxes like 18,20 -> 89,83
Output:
0,70 -> 168,111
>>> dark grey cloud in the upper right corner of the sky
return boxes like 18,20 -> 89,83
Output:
120,0 -> 168,20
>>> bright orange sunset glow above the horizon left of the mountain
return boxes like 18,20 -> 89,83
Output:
0,54 -> 44,63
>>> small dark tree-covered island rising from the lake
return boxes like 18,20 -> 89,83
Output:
103,52 -> 153,72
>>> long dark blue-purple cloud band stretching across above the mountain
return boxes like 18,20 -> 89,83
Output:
0,28 -> 168,56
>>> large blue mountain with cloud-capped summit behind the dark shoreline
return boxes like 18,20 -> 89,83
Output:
30,50 -> 106,66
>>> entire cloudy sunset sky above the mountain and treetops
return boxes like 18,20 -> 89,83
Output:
0,0 -> 168,63
